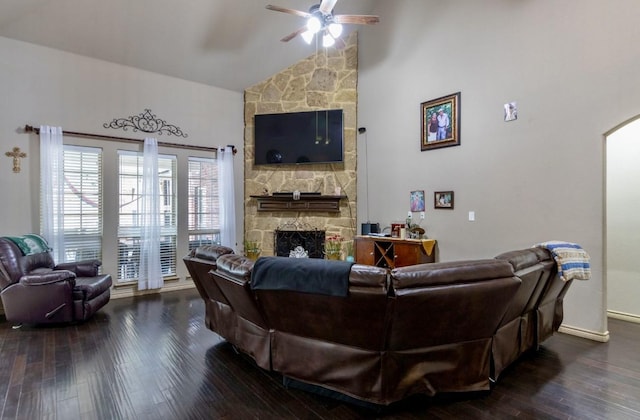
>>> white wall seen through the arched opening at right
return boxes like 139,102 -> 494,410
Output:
606,119 -> 640,320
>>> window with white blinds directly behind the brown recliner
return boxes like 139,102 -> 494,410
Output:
63,145 -> 102,262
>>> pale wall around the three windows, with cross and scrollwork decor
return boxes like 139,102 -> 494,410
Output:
0,37 -> 244,284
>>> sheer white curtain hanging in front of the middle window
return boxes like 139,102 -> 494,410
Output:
138,138 -> 164,290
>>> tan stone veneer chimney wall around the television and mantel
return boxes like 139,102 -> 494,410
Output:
244,32 -> 358,256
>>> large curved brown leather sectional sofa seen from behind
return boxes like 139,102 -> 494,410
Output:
184,247 -> 570,405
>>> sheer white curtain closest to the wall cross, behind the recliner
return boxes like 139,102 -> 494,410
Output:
40,125 -> 64,263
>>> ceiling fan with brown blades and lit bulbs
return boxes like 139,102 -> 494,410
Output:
266,0 -> 380,47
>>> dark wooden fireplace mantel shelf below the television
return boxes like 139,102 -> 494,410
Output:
251,193 -> 347,213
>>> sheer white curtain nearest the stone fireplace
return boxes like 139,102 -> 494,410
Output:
218,146 -> 237,251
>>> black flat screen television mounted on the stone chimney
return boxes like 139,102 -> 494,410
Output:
254,109 -> 344,165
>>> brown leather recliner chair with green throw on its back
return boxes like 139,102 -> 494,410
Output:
0,238 -> 112,324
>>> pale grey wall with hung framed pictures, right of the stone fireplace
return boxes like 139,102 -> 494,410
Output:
358,0 -> 640,336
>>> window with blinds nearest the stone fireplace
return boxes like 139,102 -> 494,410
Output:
188,157 -> 220,250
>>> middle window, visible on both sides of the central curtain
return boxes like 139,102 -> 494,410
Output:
118,150 -> 177,281
